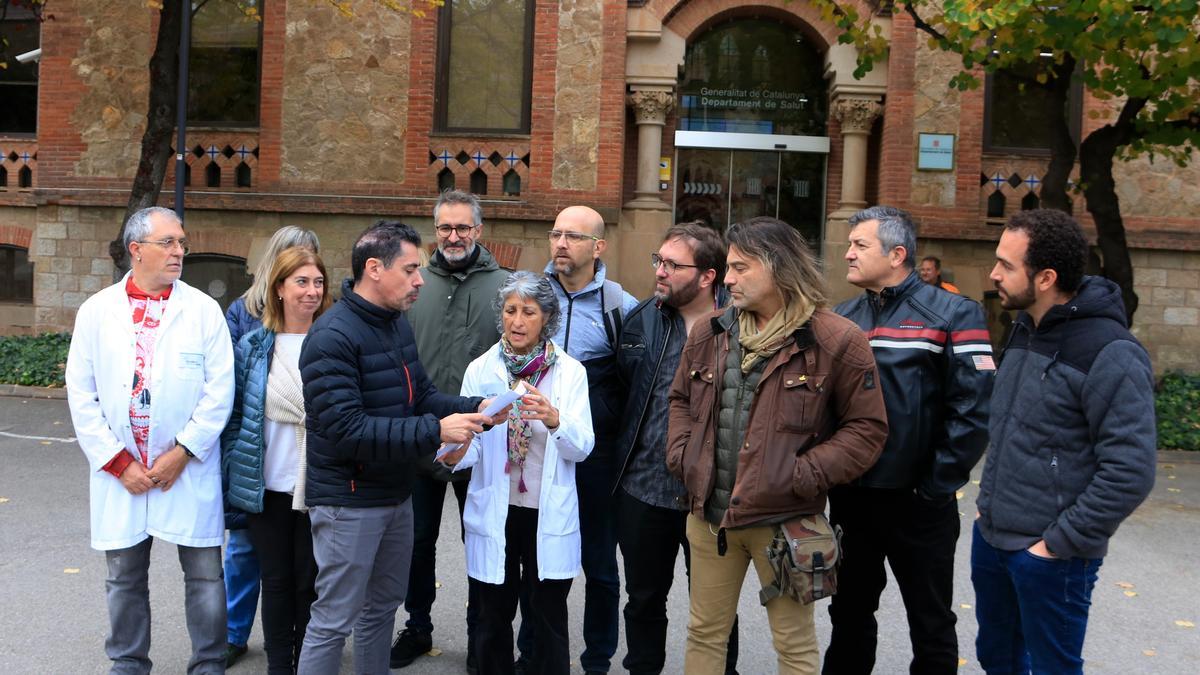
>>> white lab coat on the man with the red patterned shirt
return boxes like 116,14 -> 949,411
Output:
66,275 -> 234,550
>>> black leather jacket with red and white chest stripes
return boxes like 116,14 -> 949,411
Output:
834,271 -> 996,501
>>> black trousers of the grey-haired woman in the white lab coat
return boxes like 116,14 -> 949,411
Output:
474,506 -> 571,675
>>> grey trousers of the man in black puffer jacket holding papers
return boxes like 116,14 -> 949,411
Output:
298,500 -> 413,675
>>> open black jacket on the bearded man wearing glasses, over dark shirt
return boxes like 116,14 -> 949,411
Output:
612,286 -> 730,492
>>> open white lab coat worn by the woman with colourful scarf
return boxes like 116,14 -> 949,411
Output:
455,344 -> 595,584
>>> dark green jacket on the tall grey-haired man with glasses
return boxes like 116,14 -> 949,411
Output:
407,244 -> 509,479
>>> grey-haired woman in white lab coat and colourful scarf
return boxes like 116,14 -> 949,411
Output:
443,271 -> 594,675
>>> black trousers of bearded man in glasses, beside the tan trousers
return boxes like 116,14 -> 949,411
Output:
617,489 -> 738,675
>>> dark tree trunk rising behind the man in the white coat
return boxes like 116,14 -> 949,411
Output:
108,0 -> 186,274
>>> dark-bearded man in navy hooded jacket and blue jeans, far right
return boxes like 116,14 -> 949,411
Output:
971,209 -> 1157,674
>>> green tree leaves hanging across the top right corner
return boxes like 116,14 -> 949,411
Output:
810,0 -> 1200,157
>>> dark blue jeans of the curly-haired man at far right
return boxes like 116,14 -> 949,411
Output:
971,516 -> 1103,675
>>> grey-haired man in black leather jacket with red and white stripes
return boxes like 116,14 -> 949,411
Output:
823,207 -> 996,674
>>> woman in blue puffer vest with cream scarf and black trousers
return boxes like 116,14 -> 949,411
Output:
221,246 -> 332,673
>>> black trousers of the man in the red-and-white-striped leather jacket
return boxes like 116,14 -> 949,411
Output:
822,485 -> 960,675
